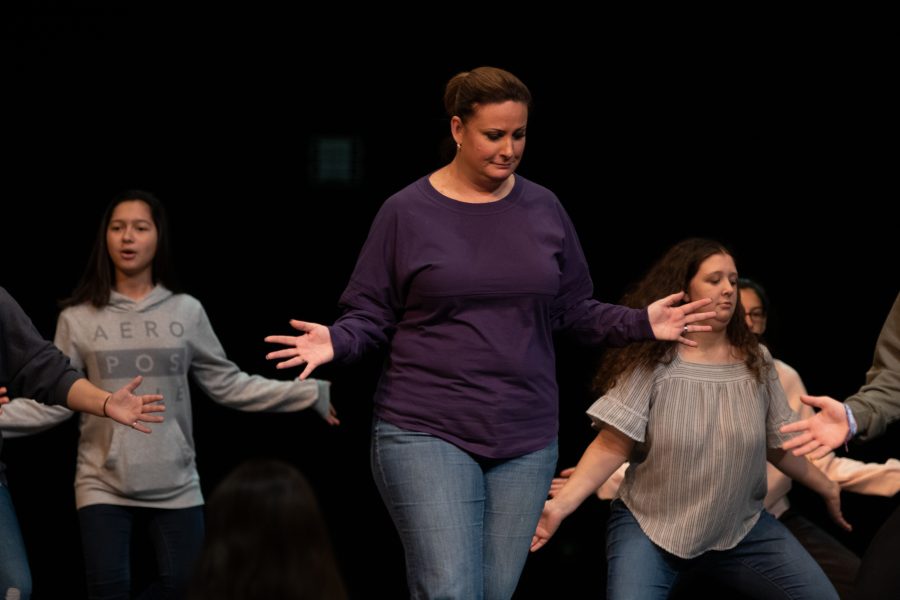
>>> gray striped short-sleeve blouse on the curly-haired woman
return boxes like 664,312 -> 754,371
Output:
587,352 -> 796,558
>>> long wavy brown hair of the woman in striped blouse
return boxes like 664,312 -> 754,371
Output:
594,238 -> 763,394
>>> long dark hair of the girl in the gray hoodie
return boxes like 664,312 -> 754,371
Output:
60,190 -> 179,308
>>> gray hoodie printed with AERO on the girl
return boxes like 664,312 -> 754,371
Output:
0,285 -> 330,508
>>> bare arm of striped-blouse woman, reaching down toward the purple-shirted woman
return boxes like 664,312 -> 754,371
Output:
531,425 -> 634,552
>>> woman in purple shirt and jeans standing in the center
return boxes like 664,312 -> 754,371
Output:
266,67 -> 711,600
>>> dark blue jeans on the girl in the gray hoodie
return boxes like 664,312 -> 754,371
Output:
78,504 -> 204,600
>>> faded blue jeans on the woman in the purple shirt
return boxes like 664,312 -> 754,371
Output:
371,418 -> 557,600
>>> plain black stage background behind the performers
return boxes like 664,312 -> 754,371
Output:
0,3 -> 900,600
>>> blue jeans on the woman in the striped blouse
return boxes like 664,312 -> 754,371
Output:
606,500 -> 838,600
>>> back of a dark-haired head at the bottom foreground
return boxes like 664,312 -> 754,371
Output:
188,459 -> 347,600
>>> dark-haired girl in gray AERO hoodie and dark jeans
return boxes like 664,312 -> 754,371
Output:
0,190 -> 337,599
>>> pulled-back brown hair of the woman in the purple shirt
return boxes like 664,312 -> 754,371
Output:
444,67 -> 531,121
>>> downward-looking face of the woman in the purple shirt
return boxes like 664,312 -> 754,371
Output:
450,100 -> 528,182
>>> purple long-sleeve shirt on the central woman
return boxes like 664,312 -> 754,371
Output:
331,175 -> 653,458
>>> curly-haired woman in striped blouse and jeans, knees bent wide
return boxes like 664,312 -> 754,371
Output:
532,238 -> 850,600
